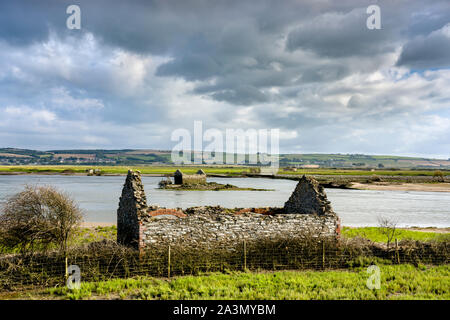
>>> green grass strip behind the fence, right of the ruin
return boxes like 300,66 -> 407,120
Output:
342,227 -> 450,242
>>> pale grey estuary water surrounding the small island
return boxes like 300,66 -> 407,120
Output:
0,175 -> 450,228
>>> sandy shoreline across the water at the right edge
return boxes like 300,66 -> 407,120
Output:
350,182 -> 450,192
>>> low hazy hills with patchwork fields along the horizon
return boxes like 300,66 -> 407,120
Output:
0,148 -> 450,169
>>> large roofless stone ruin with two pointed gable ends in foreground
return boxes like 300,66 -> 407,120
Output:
117,171 -> 340,250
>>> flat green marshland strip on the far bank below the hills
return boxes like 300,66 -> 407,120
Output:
0,165 -> 450,177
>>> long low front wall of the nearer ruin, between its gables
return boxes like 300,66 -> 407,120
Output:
139,207 -> 339,248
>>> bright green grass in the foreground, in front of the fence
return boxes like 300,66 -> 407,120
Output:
21,265 -> 450,300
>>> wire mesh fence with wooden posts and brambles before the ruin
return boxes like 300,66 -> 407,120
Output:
0,238 -> 449,290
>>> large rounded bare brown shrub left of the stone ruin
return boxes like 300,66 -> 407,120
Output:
0,186 -> 82,253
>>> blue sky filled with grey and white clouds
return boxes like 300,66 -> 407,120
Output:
0,0 -> 450,159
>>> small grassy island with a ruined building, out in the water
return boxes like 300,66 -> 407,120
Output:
158,170 -> 273,191
